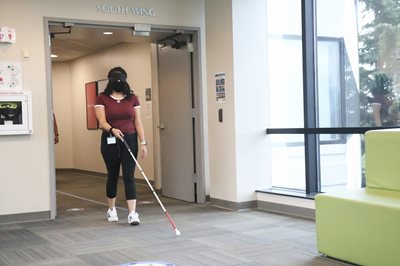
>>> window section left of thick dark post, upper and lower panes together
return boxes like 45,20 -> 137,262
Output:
267,0 -> 305,190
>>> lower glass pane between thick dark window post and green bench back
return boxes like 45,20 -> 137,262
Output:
320,134 -> 364,192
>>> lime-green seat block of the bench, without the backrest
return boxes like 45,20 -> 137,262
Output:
315,188 -> 400,266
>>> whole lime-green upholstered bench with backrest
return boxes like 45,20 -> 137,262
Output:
315,129 -> 400,266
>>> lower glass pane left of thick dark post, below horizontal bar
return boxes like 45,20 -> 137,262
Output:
271,135 -> 305,191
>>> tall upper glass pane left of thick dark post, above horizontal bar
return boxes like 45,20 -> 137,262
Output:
267,0 -> 304,129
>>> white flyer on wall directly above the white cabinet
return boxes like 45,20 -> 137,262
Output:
0,61 -> 22,92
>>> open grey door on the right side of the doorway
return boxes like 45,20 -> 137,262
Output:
158,46 -> 196,202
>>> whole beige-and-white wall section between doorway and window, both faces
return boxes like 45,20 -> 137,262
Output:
206,0 -> 270,205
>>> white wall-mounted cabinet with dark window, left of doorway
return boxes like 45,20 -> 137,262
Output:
0,91 -> 33,135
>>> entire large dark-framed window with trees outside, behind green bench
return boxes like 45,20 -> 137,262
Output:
267,0 -> 400,193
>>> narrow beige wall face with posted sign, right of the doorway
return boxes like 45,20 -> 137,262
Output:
205,0 -> 237,201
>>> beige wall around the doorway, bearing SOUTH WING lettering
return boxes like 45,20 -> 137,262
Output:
0,0 -> 205,215
